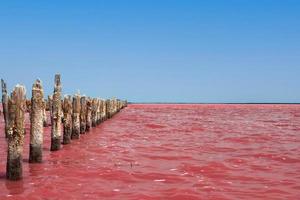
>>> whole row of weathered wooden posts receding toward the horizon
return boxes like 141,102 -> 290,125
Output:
1,74 -> 127,180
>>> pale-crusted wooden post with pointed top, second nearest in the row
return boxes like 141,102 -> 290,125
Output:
29,80 -> 45,163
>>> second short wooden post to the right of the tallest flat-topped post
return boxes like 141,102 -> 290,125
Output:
71,94 -> 81,139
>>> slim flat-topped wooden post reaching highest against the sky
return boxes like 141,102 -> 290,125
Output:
51,74 -> 61,151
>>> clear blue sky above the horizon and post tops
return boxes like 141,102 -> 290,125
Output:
0,0 -> 300,102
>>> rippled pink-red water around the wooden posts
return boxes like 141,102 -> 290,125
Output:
0,104 -> 300,200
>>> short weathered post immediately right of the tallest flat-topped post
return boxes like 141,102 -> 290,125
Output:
63,95 -> 73,144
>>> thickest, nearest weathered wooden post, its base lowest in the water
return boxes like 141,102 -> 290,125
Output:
6,85 -> 26,180
